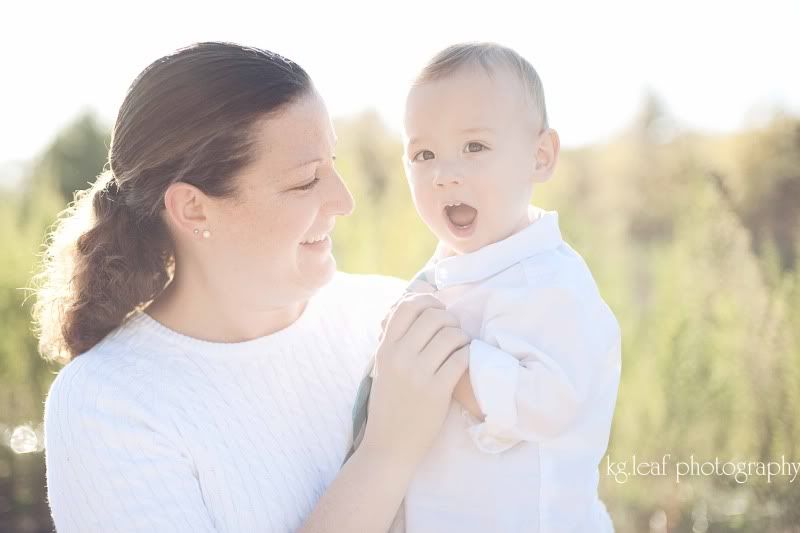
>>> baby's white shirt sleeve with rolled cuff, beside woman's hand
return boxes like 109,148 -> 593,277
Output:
467,285 -> 620,453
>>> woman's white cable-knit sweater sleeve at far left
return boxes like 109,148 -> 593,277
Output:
44,355 -> 216,533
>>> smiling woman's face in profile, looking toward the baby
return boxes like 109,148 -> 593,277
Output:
209,91 -> 353,309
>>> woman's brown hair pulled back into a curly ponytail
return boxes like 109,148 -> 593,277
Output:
33,42 -> 313,362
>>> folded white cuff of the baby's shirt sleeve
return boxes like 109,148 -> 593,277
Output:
465,339 -> 521,453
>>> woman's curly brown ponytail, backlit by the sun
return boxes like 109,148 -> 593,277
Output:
33,170 -> 172,362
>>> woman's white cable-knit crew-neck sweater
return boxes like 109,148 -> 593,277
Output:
44,273 -> 405,533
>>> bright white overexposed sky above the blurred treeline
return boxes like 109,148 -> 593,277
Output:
0,0 -> 800,164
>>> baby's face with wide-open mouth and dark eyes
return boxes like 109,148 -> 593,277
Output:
404,67 -> 539,254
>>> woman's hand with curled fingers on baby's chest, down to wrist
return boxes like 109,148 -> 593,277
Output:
361,294 -> 471,464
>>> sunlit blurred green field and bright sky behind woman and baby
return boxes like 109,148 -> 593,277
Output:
0,0 -> 800,533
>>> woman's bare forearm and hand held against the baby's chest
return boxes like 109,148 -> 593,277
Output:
301,294 -> 470,533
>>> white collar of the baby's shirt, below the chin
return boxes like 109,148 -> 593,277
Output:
420,206 -> 563,290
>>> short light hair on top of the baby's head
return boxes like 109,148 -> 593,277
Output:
412,42 -> 549,129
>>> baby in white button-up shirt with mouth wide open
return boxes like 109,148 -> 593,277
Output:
354,43 -> 621,533
